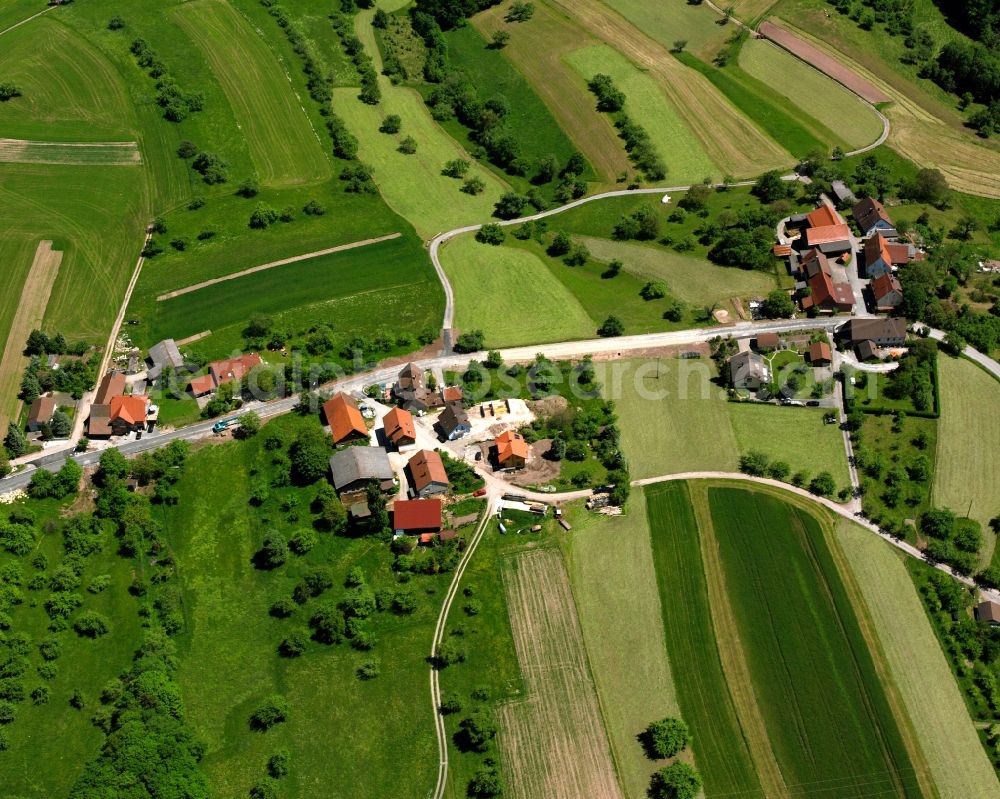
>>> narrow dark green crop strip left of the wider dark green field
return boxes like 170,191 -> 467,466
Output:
645,483 -> 762,796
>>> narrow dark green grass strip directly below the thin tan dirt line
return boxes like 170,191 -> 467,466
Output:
149,235 -> 440,341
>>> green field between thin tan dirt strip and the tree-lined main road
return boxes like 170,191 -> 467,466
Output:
142,235 -> 443,355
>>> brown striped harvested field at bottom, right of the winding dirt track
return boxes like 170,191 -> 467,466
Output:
498,549 -> 623,799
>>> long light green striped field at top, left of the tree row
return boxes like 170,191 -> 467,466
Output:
172,0 -> 333,186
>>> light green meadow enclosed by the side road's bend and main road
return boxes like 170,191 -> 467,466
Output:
441,235 -> 599,347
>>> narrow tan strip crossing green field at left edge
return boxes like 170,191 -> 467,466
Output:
0,241 -> 62,432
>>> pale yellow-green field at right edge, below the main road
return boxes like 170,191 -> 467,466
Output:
934,355 -> 1000,565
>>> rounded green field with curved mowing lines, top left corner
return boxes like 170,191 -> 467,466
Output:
0,16 -> 136,141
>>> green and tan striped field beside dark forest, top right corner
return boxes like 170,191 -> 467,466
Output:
774,11 -> 1000,197
